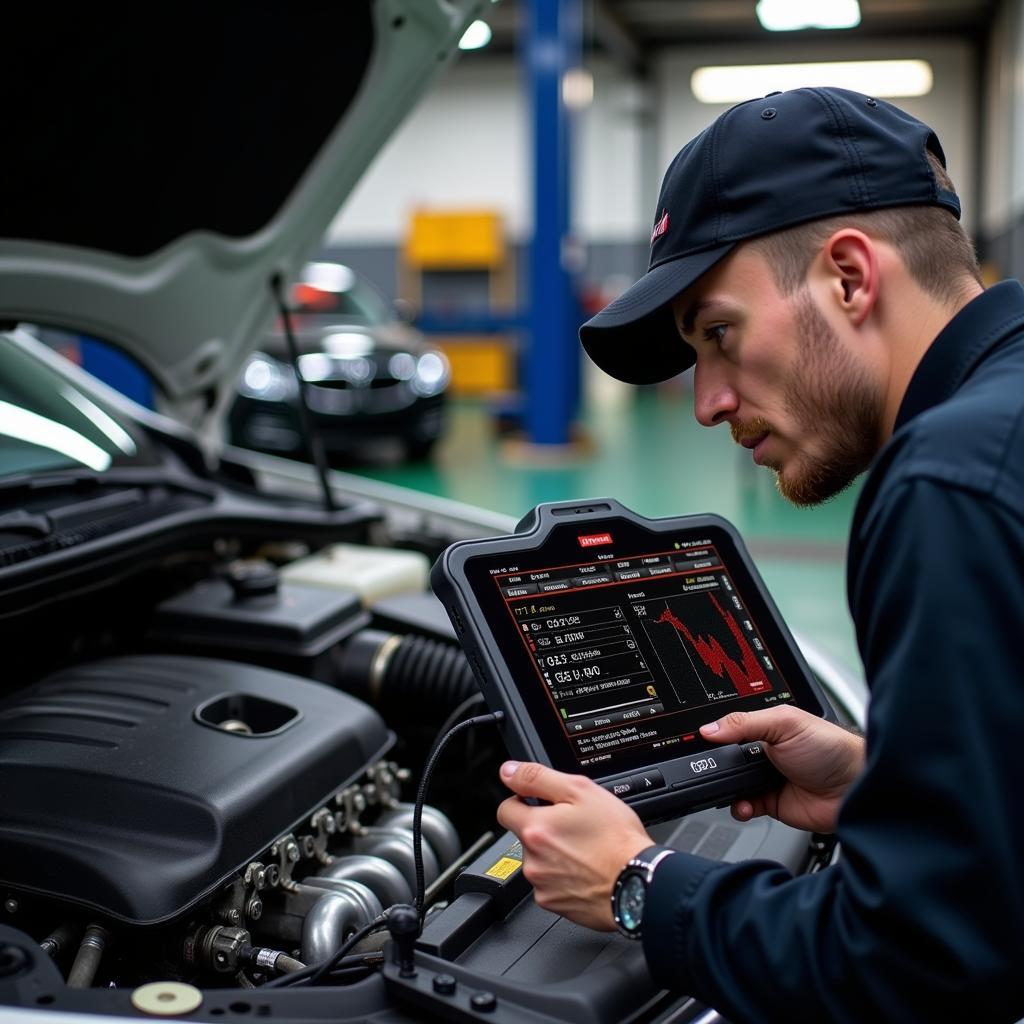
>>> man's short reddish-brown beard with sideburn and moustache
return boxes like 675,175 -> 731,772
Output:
732,289 -> 883,508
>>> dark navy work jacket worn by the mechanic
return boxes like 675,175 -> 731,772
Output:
643,282 -> 1024,1024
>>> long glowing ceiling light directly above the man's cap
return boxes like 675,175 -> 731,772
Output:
690,60 -> 932,103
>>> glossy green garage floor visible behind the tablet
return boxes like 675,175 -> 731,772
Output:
356,389 -> 861,675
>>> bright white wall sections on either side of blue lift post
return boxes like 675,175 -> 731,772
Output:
328,58 -> 650,244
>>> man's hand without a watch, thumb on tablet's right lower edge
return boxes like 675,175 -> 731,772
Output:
700,708 -> 864,833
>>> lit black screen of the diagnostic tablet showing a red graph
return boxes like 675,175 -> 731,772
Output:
467,520 -> 809,777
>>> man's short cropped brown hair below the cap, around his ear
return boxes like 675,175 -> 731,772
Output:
751,151 -> 981,302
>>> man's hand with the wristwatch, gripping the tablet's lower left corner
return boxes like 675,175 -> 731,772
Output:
498,761 -> 654,932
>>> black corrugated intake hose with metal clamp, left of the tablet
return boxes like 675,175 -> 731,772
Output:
336,630 -> 479,719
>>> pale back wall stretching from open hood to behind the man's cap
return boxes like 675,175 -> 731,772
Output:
328,40 -> 974,245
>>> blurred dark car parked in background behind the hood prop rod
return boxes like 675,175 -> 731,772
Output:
228,262 -> 451,461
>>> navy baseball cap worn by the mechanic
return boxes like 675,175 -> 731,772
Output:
580,89 -> 961,384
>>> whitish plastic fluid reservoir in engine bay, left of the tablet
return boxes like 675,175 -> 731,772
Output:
281,544 -> 430,604
